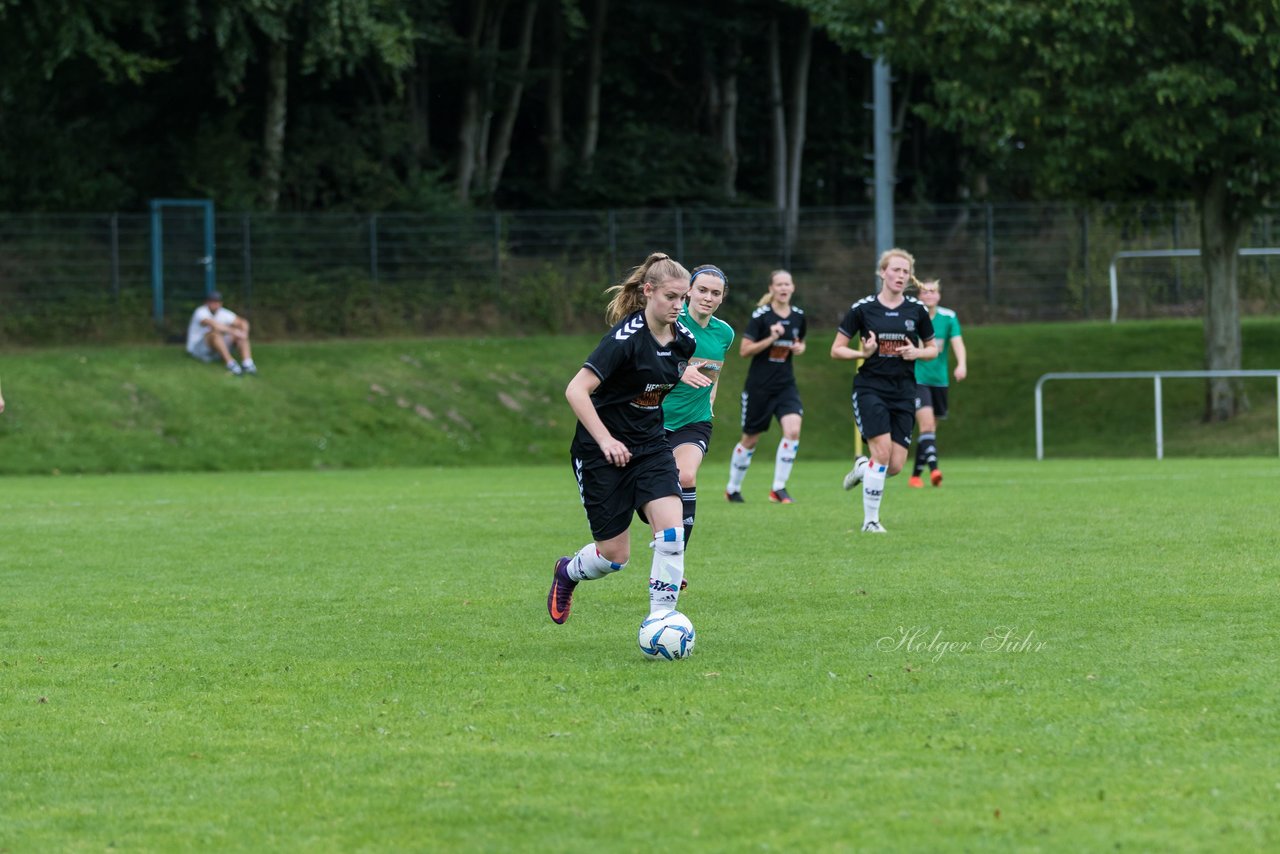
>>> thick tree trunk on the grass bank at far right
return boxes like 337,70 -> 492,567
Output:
1197,173 -> 1248,421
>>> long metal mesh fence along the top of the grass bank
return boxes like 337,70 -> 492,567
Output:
0,204 -> 1280,342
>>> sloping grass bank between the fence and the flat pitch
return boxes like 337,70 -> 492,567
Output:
0,318 -> 1280,474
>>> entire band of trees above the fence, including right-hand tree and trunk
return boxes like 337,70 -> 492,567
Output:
0,0 -> 1280,416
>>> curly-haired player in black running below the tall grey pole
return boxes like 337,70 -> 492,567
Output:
831,250 -> 938,534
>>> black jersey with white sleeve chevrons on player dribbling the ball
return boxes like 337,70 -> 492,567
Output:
573,310 -> 698,458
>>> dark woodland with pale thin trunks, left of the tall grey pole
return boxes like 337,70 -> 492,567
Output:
0,0 -> 890,210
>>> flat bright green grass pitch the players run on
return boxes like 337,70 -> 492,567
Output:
0,458 -> 1280,851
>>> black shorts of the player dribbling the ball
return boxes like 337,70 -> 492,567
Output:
571,448 -> 680,542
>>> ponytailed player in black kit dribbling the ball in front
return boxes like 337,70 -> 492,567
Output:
547,252 -> 712,624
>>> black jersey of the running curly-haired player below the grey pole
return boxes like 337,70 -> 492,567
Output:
837,294 -> 933,398
